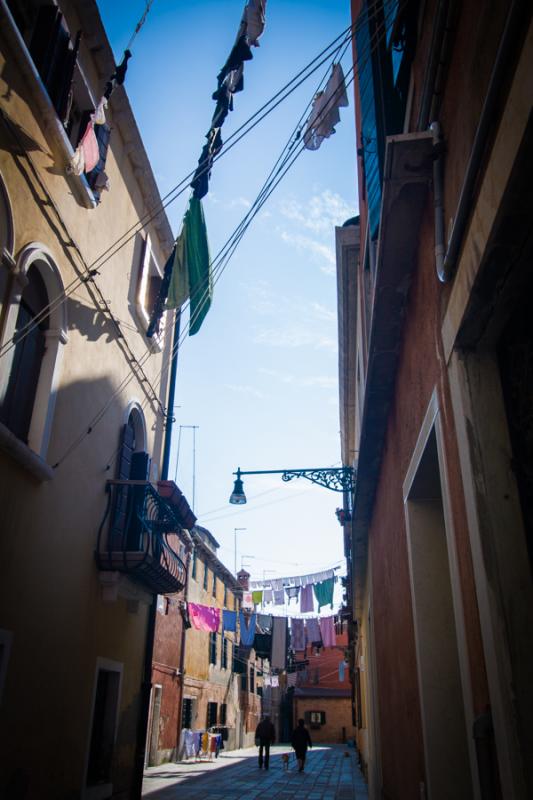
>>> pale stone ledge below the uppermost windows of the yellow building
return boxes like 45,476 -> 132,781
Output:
0,0 -> 97,208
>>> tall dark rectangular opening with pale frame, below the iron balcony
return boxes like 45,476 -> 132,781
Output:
86,659 -> 122,790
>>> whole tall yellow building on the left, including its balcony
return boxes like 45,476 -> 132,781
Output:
0,0 -> 189,800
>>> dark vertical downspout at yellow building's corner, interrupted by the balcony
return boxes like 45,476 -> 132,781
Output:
132,309 -> 181,800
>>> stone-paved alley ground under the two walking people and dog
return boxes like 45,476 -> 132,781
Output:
143,745 -> 368,800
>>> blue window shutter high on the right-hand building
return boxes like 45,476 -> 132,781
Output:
355,3 -> 382,239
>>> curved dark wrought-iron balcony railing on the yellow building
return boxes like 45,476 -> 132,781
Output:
96,480 -> 186,594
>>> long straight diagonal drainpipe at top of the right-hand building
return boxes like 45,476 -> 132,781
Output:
437,0 -> 526,283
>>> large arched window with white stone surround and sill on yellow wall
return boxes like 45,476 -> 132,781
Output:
0,244 -> 67,468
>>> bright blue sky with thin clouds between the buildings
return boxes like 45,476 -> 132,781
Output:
99,0 -> 357,600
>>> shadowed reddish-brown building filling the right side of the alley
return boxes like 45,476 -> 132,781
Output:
336,0 -> 533,800
